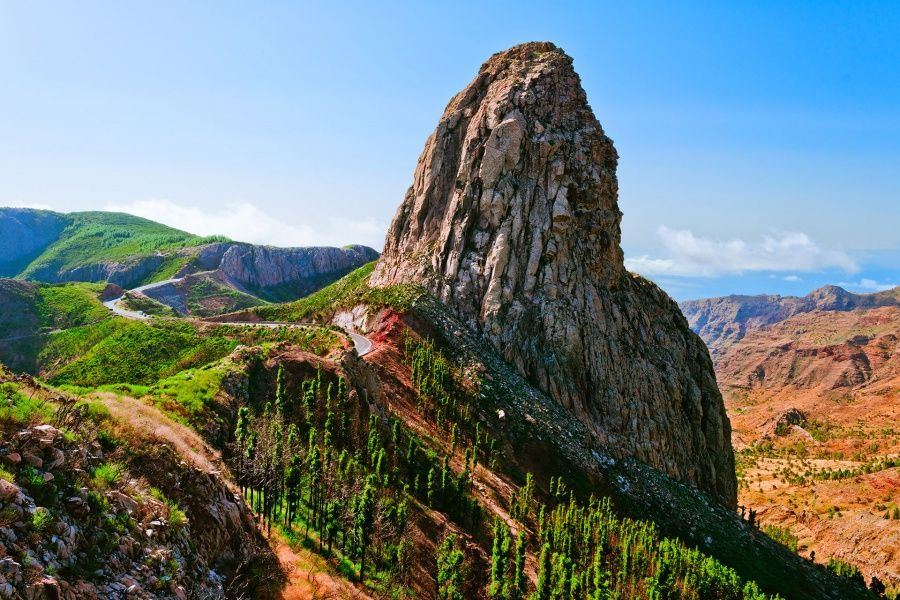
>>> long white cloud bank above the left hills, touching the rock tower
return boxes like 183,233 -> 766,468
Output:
104,199 -> 384,250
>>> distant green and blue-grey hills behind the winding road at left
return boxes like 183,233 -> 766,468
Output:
0,208 -> 378,315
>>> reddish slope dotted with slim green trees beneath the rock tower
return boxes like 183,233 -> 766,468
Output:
0,271 -> 865,598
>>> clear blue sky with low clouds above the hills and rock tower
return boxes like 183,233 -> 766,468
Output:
0,1 -> 900,299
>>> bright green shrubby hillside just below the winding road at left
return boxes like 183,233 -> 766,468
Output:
0,279 -> 343,386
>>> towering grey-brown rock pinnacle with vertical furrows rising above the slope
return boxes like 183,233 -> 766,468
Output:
371,43 -> 736,505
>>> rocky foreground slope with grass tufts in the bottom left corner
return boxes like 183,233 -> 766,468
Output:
0,366 -> 283,600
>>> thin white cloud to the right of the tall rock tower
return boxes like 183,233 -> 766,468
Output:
625,226 -> 859,277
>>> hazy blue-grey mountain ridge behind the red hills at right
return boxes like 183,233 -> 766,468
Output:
679,285 -> 900,360
